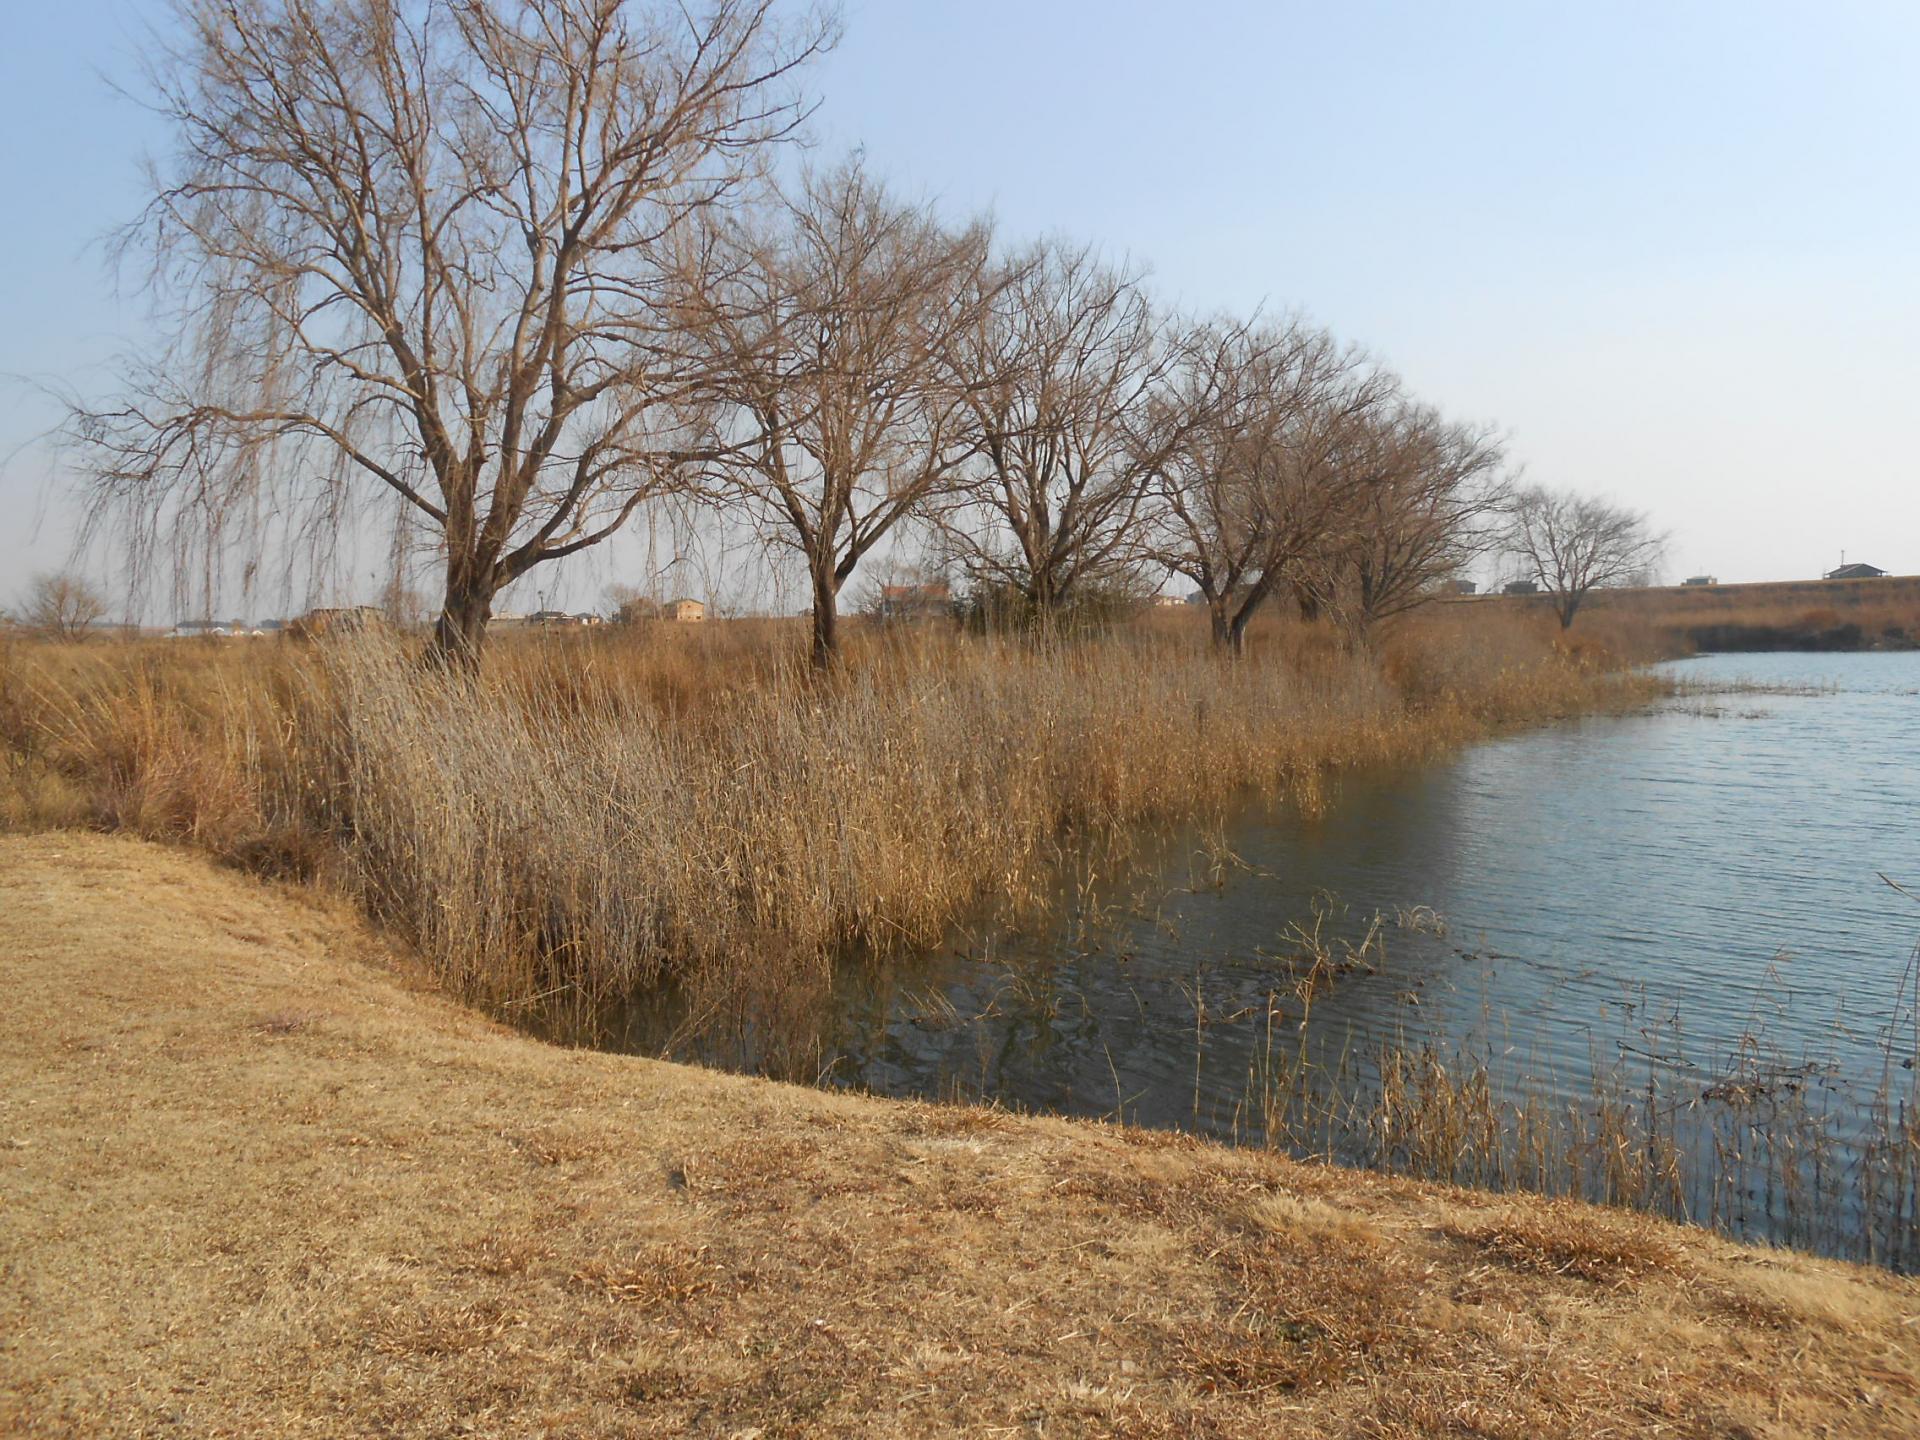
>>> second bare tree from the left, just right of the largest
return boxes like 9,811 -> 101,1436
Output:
687,159 -> 989,666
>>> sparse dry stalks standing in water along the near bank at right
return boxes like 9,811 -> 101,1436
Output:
1196,887 -> 1920,1273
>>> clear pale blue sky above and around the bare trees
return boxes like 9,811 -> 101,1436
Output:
0,0 -> 1920,605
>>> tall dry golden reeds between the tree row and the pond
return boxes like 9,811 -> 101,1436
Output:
0,612 -> 1659,1033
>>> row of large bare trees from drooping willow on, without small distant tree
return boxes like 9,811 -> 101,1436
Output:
60,0 -> 1651,664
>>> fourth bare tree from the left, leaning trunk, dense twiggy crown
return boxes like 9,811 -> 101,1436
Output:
1156,323 -> 1394,655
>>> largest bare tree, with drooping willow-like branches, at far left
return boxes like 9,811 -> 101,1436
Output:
71,0 -> 831,662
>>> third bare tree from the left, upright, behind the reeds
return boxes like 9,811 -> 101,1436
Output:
939,242 -> 1175,620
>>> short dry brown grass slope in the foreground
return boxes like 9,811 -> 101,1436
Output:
0,833 -> 1920,1440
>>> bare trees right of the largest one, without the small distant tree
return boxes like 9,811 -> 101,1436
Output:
680,163 -> 1501,662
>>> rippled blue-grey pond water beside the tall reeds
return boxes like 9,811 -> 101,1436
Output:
614,653 -> 1920,1248
